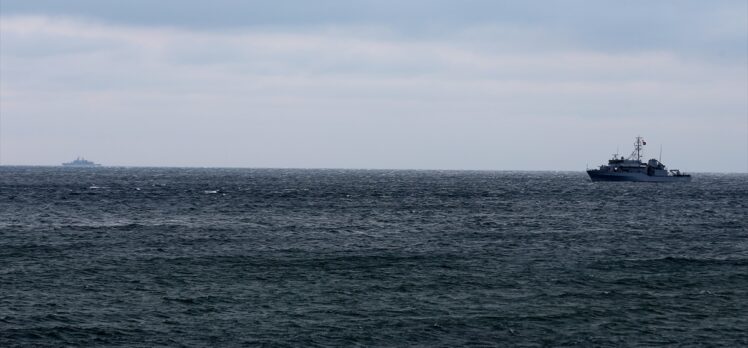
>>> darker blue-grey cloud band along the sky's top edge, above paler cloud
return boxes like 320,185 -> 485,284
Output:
3,0 -> 748,62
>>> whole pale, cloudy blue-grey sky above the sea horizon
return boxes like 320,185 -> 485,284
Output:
0,0 -> 748,173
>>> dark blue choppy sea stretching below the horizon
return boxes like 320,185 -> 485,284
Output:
0,167 -> 748,347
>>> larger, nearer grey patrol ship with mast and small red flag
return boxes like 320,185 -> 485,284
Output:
587,137 -> 691,182
